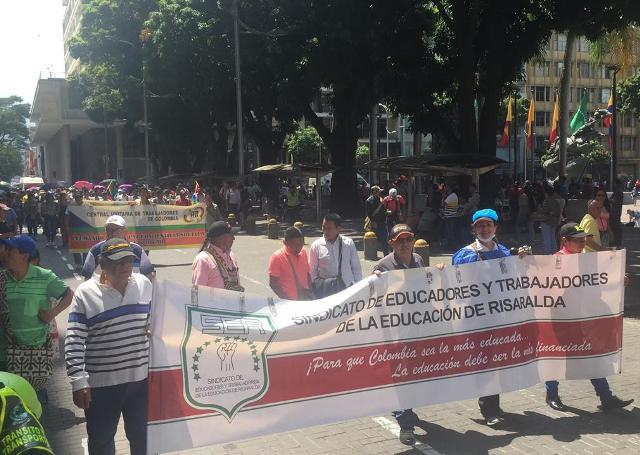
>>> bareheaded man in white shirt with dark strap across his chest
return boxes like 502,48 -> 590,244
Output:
309,213 -> 362,298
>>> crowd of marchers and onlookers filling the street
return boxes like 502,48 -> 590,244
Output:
0,173 -> 633,454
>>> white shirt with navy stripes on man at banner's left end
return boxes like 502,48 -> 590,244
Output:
64,273 -> 153,391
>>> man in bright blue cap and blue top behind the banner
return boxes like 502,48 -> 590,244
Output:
451,209 -> 529,426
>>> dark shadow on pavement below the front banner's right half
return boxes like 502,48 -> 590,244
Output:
398,407 -> 640,455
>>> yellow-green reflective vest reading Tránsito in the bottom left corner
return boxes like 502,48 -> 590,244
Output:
0,383 -> 53,455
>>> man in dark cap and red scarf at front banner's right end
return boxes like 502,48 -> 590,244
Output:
544,223 -> 633,412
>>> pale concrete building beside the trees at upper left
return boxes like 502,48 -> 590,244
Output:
30,0 -> 145,183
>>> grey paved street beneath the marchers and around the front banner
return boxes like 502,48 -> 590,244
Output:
38,212 -> 640,455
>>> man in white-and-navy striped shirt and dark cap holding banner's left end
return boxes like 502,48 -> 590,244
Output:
65,238 -> 152,455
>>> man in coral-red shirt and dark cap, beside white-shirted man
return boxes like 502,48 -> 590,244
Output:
268,227 -> 312,300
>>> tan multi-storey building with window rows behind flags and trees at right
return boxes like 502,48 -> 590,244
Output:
519,33 -> 640,176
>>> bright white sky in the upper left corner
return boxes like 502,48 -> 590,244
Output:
0,0 -> 65,103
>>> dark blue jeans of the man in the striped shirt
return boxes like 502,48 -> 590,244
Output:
85,379 -> 147,455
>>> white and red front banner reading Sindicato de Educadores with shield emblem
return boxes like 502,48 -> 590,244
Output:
148,250 -> 625,453
